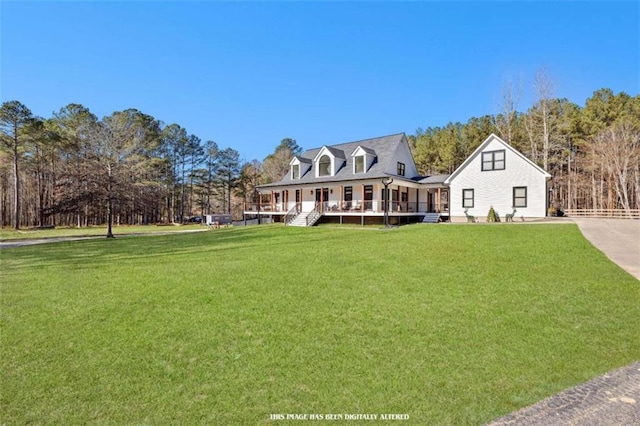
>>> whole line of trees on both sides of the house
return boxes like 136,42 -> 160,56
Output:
0,81 -> 640,234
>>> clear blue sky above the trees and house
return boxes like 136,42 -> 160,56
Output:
0,0 -> 640,161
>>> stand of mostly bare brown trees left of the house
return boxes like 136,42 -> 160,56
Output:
0,101 -> 255,233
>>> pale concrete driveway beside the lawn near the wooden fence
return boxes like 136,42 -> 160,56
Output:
573,218 -> 640,280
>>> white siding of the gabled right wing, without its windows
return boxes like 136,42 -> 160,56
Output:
450,138 -> 547,220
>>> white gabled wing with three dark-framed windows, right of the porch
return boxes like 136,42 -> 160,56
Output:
445,134 -> 551,220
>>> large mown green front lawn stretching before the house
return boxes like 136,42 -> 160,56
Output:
0,224 -> 640,425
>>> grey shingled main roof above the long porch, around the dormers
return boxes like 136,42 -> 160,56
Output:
259,133 -> 411,187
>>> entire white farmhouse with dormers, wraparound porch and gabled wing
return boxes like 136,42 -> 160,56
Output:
244,133 -> 550,226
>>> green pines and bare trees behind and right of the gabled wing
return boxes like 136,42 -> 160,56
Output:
409,81 -> 640,215
